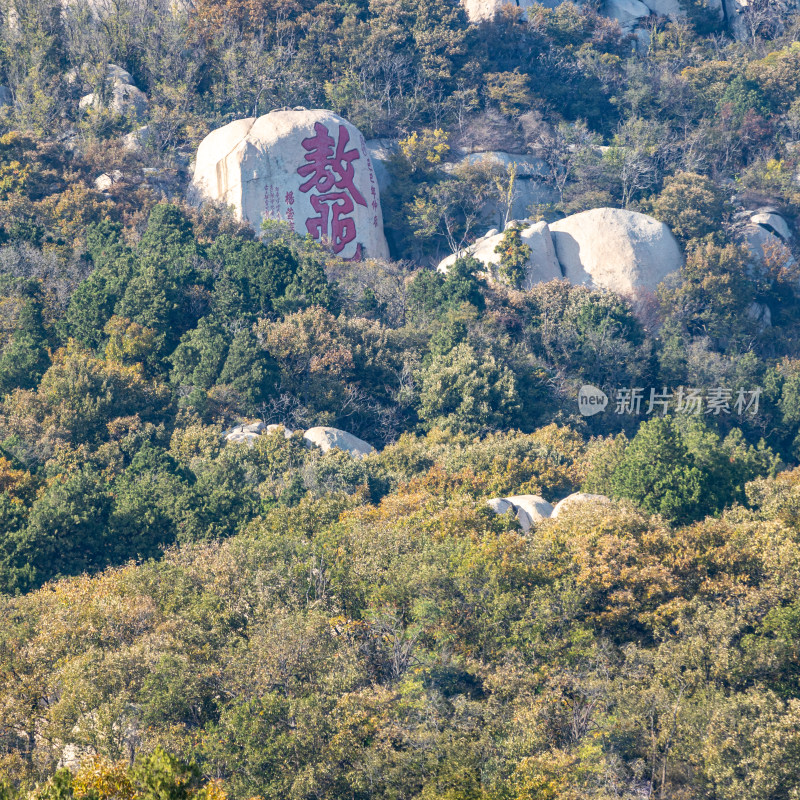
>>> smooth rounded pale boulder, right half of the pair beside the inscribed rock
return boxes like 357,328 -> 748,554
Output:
550,208 -> 683,296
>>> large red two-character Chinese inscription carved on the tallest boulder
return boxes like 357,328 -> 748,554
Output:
297,122 -> 367,254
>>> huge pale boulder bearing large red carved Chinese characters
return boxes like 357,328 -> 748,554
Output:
189,109 -> 389,260
